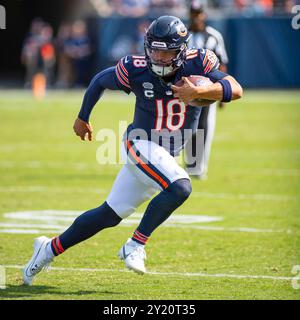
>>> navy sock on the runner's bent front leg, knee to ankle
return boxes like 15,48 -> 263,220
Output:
132,179 -> 192,244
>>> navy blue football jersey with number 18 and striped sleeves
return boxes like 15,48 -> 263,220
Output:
115,49 -> 226,154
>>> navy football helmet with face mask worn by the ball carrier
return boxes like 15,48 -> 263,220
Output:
144,16 -> 190,77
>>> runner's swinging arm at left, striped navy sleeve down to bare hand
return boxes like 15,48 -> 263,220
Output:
73,58 -> 131,141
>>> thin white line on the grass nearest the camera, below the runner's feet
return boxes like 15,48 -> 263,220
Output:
4,265 -> 294,281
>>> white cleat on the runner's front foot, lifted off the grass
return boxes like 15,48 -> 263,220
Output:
118,238 -> 146,274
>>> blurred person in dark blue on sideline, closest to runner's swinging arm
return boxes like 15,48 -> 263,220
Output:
64,20 -> 92,87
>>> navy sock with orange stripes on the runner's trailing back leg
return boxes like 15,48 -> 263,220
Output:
51,202 -> 122,255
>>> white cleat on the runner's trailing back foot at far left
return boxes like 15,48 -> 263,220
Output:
23,236 -> 53,286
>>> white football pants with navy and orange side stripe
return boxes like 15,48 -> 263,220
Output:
106,140 -> 190,219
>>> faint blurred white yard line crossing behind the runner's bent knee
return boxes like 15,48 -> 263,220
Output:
0,186 -> 300,201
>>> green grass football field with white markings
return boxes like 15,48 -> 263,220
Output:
0,91 -> 300,300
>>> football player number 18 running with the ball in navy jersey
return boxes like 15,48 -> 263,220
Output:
23,16 -> 242,284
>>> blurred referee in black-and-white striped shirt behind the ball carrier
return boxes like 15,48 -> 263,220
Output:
185,1 -> 228,179
